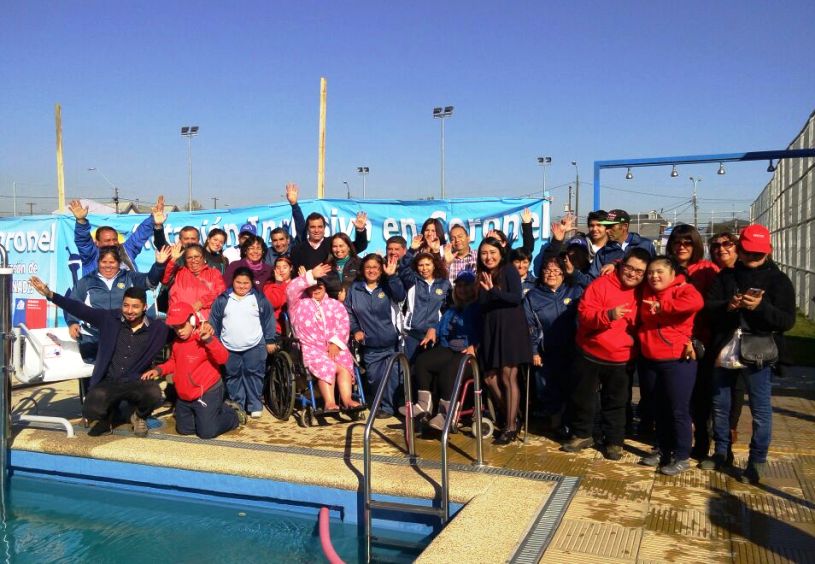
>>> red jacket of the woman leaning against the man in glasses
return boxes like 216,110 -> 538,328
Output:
637,274 -> 705,360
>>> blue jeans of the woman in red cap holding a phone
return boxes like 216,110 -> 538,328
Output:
713,366 -> 773,463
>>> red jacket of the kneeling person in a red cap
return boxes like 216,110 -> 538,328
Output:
158,329 -> 229,401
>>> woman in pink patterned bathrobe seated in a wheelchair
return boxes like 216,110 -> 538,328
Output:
286,264 -> 359,412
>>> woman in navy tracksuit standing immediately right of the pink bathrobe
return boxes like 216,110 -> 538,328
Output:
345,253 -> 405,418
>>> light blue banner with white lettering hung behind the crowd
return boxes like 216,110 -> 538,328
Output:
0,198 -> 550,328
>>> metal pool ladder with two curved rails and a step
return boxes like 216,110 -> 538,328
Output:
363,352 -> 484,562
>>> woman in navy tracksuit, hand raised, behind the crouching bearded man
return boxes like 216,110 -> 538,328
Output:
65,246 -> 171,364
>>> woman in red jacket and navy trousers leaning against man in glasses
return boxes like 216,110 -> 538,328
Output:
637,256 -> 705,476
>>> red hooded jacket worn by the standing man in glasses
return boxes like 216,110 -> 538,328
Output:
577,272 -> 641,364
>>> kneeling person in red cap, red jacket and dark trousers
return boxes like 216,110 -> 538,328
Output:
142,303 -> 246,439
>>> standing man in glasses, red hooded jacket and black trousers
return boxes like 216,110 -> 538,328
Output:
562,247 -> 651,460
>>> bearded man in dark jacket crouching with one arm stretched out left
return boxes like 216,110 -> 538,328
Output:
30,276 -> 168,437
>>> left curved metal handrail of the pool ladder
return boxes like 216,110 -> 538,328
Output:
362,352 -> 416,562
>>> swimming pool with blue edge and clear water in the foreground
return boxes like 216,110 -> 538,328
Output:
0,451 -> 460,563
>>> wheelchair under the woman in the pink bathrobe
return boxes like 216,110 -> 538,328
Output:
264,317 -> 368,427
